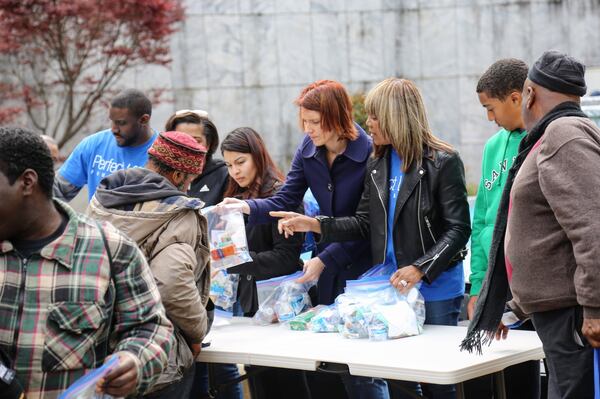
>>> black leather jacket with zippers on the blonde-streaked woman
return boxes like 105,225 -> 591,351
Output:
319,148 -> 471,283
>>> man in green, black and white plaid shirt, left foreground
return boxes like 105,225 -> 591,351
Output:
0,128 -> 173,399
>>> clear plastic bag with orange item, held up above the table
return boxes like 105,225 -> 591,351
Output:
202,205 -> 252,269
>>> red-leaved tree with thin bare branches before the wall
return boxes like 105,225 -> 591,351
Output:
0,0 -> 184,146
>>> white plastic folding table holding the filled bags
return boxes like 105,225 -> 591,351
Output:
197,318 -> 544,395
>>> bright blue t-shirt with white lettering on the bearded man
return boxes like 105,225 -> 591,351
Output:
58,129 -> 158,200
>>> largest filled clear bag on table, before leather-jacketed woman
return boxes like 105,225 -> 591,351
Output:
336,277 -> 425,341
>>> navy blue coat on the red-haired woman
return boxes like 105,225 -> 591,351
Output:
247,125 -> 373,304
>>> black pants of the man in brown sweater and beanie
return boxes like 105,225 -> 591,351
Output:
532,306 -> 594,399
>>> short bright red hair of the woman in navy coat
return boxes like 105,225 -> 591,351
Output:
294,80 -> 358,140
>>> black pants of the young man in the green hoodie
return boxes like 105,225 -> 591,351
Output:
463,321 -> 540,399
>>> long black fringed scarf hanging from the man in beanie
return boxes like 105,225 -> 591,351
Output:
460,102 -> 586,354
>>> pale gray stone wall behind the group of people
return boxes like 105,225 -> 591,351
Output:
98,0 -> 600,188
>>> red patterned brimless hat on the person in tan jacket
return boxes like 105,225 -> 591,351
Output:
148,132 -> 206,175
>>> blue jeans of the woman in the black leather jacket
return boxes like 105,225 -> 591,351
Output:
390,296 -> 463,399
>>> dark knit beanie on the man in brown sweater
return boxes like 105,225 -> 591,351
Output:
528,50 -> 587,97
